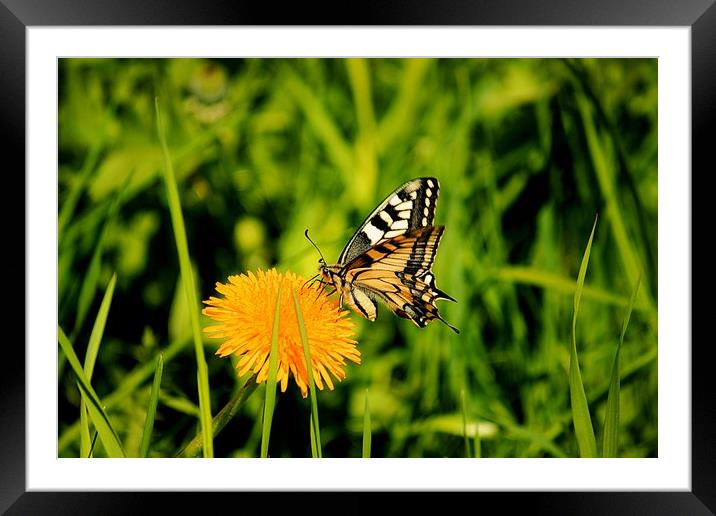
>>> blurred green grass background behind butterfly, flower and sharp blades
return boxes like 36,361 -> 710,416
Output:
58,59 -> 658,457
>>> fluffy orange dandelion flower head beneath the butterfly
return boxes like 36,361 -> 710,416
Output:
202,269 -> 360,398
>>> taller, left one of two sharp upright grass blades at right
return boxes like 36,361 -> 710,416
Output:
569,217 -> 597,457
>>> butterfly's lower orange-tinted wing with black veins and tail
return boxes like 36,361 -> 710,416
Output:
344,226 -> 459,333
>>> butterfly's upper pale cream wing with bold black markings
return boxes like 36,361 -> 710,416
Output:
338,177 -> 440,265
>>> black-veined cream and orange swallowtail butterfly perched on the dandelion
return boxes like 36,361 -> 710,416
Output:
306,177 -> 460,333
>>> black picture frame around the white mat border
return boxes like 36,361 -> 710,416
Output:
0,0 -> 716,514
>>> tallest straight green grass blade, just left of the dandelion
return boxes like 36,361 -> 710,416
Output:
154,97 -> 214,457
